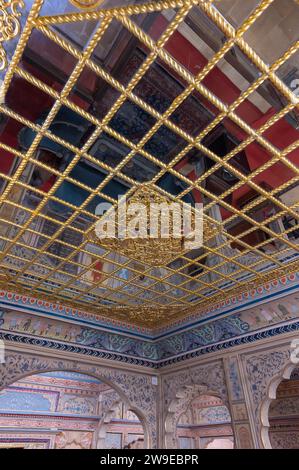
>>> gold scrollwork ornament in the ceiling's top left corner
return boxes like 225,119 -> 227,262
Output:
0,0 -> 25,70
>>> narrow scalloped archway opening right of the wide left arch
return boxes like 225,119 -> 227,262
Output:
165,384 -> 234,449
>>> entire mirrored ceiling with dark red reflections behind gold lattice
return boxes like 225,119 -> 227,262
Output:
0,0 -> 299,326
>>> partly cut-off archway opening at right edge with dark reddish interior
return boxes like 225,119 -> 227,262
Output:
269,368 -> 299,449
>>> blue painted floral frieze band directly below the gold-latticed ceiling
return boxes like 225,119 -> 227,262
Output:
0,294 -> 299,368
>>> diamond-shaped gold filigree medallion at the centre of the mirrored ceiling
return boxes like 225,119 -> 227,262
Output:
89,184 -> 217,266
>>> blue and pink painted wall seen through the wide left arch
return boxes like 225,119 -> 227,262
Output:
0,372 -> 102,449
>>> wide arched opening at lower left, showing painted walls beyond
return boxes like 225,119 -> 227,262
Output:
0,370 -> 144,449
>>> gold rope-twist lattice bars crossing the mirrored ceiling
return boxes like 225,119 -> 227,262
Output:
0,0 -> 299,326
